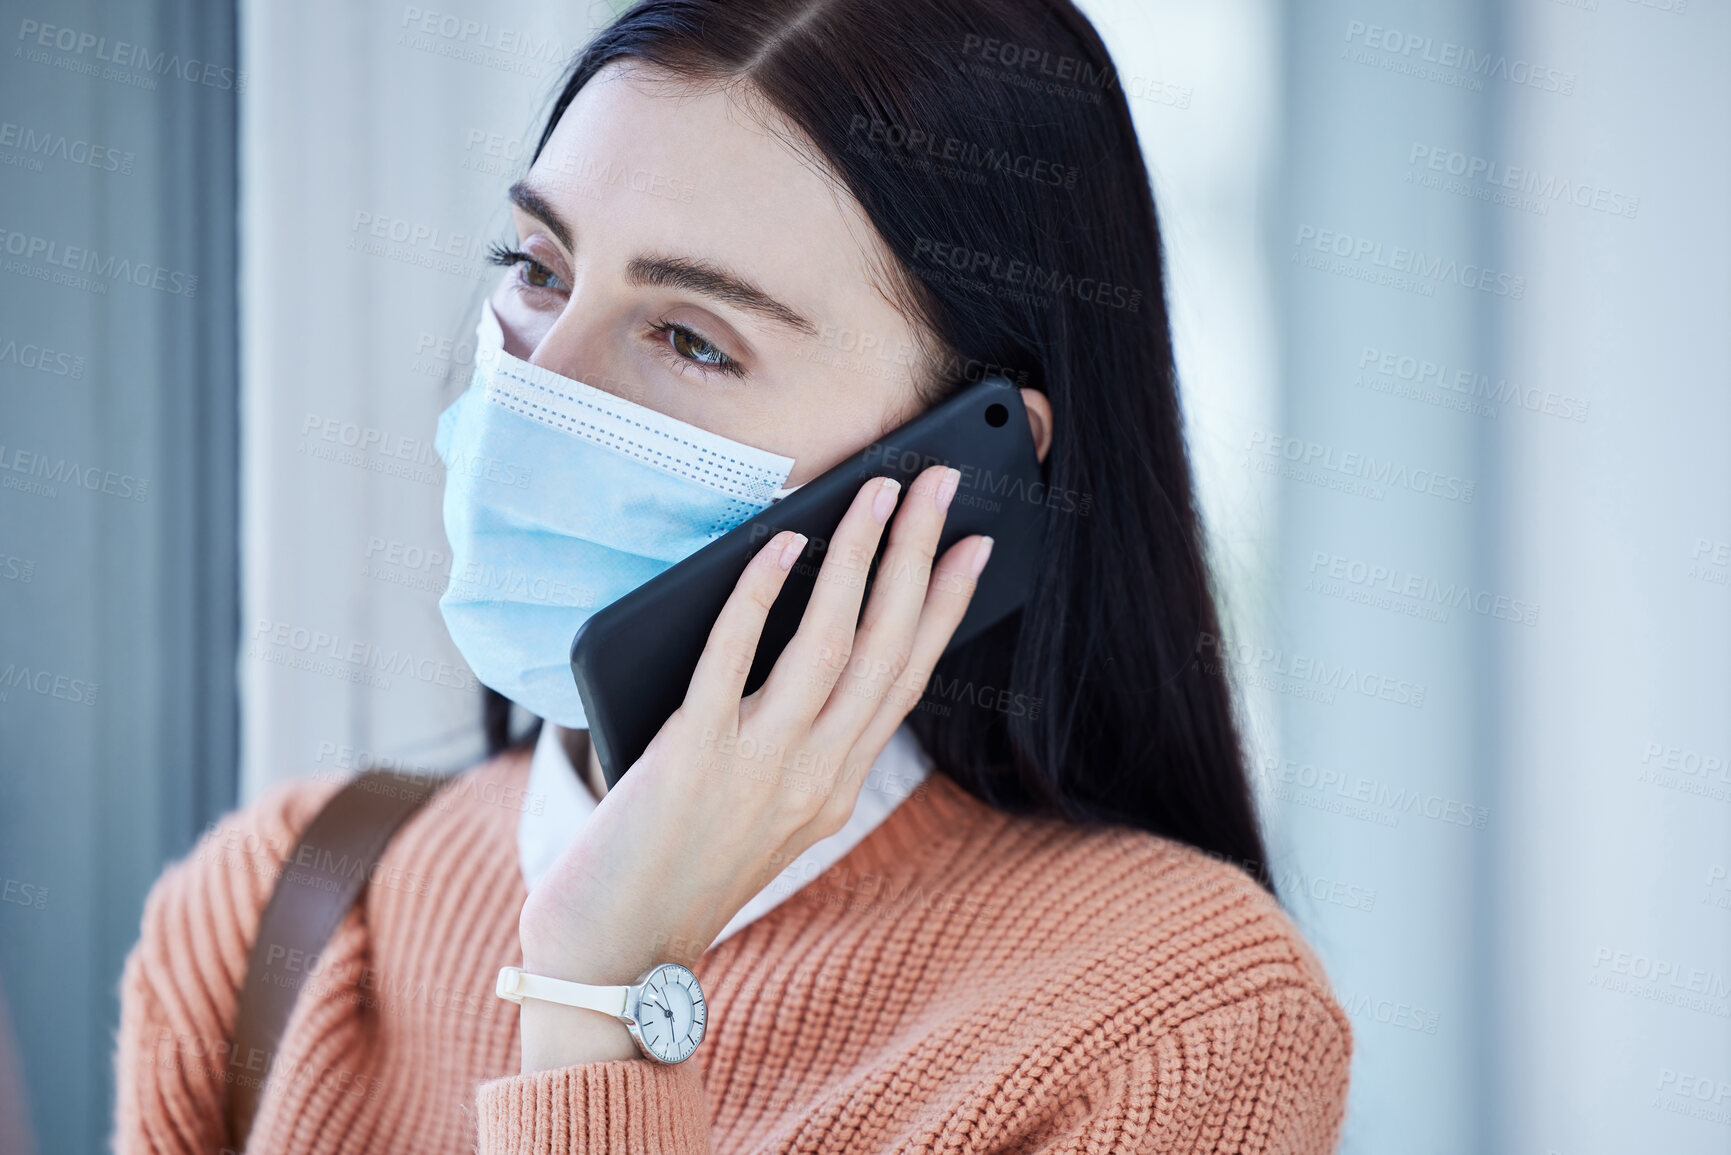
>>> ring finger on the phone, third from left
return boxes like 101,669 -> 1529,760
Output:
815,466 -> 973,746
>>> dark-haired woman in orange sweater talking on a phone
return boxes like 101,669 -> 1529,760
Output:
118,0 -> 1352,1153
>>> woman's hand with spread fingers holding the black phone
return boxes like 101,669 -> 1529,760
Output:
518,466 -> 990,1056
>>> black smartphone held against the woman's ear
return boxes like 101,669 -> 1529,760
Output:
571,377 -> 1047,788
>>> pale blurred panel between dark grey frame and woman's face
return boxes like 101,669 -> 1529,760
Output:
231,0 -> 611,798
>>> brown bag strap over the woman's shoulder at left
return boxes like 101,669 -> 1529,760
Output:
227,771 -> 447,1152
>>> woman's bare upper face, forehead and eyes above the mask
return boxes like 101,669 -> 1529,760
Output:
492,62 -> 926,485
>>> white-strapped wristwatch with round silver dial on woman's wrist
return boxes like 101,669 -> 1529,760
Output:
495,963 -> 710,1063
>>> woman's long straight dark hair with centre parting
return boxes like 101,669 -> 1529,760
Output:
486,0 -> 1272,890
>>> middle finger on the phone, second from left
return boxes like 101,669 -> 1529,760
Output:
760,478 -> 902,727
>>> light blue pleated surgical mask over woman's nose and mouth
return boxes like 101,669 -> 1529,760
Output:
433,305 -> 798,729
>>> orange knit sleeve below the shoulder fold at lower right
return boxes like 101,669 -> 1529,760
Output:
988,987 -> 1352,1155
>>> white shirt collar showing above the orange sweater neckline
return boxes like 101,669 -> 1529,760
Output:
518,722 -> 931,947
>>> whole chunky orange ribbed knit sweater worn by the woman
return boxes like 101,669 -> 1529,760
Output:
114,753 -> 1352,1155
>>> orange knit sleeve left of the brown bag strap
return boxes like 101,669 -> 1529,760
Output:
113,783 -> 336,1155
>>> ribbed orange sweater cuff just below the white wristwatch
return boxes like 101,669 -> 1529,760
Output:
476,1058 -> 710,1155
